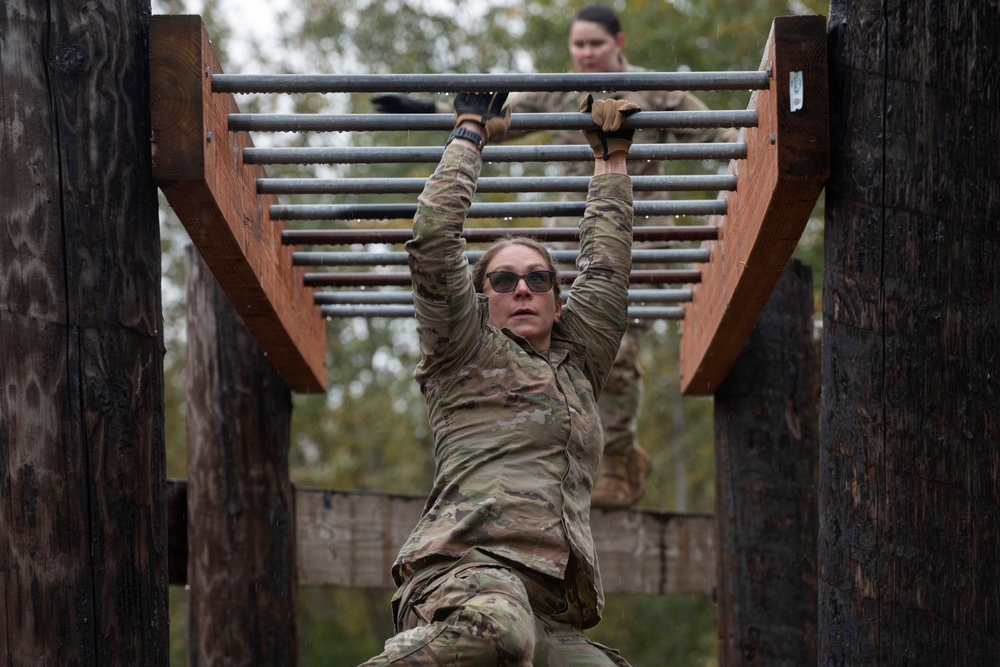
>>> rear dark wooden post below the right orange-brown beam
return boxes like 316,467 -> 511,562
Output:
715,261 -> 819,667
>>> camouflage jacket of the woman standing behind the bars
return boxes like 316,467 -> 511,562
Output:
504,58 -> 738,180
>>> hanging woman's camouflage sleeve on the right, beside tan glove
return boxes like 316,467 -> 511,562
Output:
559,174 -> 632,395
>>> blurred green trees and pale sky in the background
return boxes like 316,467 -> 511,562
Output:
153,0 -> 827,666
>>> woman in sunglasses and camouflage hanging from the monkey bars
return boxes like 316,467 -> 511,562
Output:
364,93 -> 639,667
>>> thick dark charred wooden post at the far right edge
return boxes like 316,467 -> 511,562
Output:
819,0 -> 1000,665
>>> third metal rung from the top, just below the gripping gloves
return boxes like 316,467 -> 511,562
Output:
243,141 -> 747,164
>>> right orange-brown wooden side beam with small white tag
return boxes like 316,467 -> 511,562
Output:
680,16 -> 830,395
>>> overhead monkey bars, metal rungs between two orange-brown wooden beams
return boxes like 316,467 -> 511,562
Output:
150,16 -> 829,394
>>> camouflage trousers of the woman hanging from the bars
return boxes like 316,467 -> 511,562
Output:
361,550 -> 629,667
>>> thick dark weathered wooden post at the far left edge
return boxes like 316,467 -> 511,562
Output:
0,0 -> 168,666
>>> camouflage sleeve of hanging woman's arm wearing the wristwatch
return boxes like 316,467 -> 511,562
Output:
406,144 -> 485,379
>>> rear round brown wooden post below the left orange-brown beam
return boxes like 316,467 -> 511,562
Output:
187,248 -> 297,665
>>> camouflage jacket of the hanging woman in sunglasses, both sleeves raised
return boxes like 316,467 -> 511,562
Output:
393,144 -> 632,627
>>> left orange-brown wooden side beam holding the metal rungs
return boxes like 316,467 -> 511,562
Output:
149,16 -> 326,392
